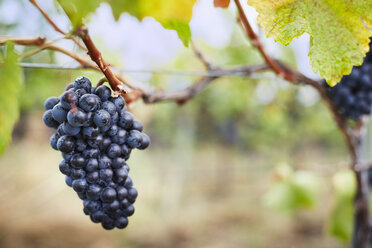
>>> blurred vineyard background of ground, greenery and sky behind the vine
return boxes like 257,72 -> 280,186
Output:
0,0 -> 356,248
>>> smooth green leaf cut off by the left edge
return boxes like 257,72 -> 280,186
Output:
0,44 -> 22,154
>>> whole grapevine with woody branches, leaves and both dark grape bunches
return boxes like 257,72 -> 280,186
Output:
0,0 -> 372,248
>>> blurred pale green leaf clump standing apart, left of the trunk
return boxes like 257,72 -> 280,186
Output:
263,165 -> 319,214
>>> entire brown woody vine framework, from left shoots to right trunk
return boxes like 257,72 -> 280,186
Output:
0,0 -> 371,244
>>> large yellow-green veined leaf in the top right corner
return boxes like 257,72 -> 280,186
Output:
248,0 -> 372,85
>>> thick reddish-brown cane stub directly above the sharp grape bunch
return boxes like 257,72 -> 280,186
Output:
76,25 -> 126,94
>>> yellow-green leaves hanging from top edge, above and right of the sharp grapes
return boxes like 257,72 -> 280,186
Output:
58,0 -> 196,46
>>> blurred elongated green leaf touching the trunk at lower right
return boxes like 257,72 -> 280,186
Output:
328,170 -> 356,243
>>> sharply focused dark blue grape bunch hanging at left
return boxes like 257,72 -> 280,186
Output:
43,77 -> 150,230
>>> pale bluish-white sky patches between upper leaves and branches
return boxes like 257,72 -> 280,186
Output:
0,0 -> 317,80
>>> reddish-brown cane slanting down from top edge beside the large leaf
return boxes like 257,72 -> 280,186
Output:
234,0 -> 294,82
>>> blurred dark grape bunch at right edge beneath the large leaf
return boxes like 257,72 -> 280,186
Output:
327,42 -> 372,120
